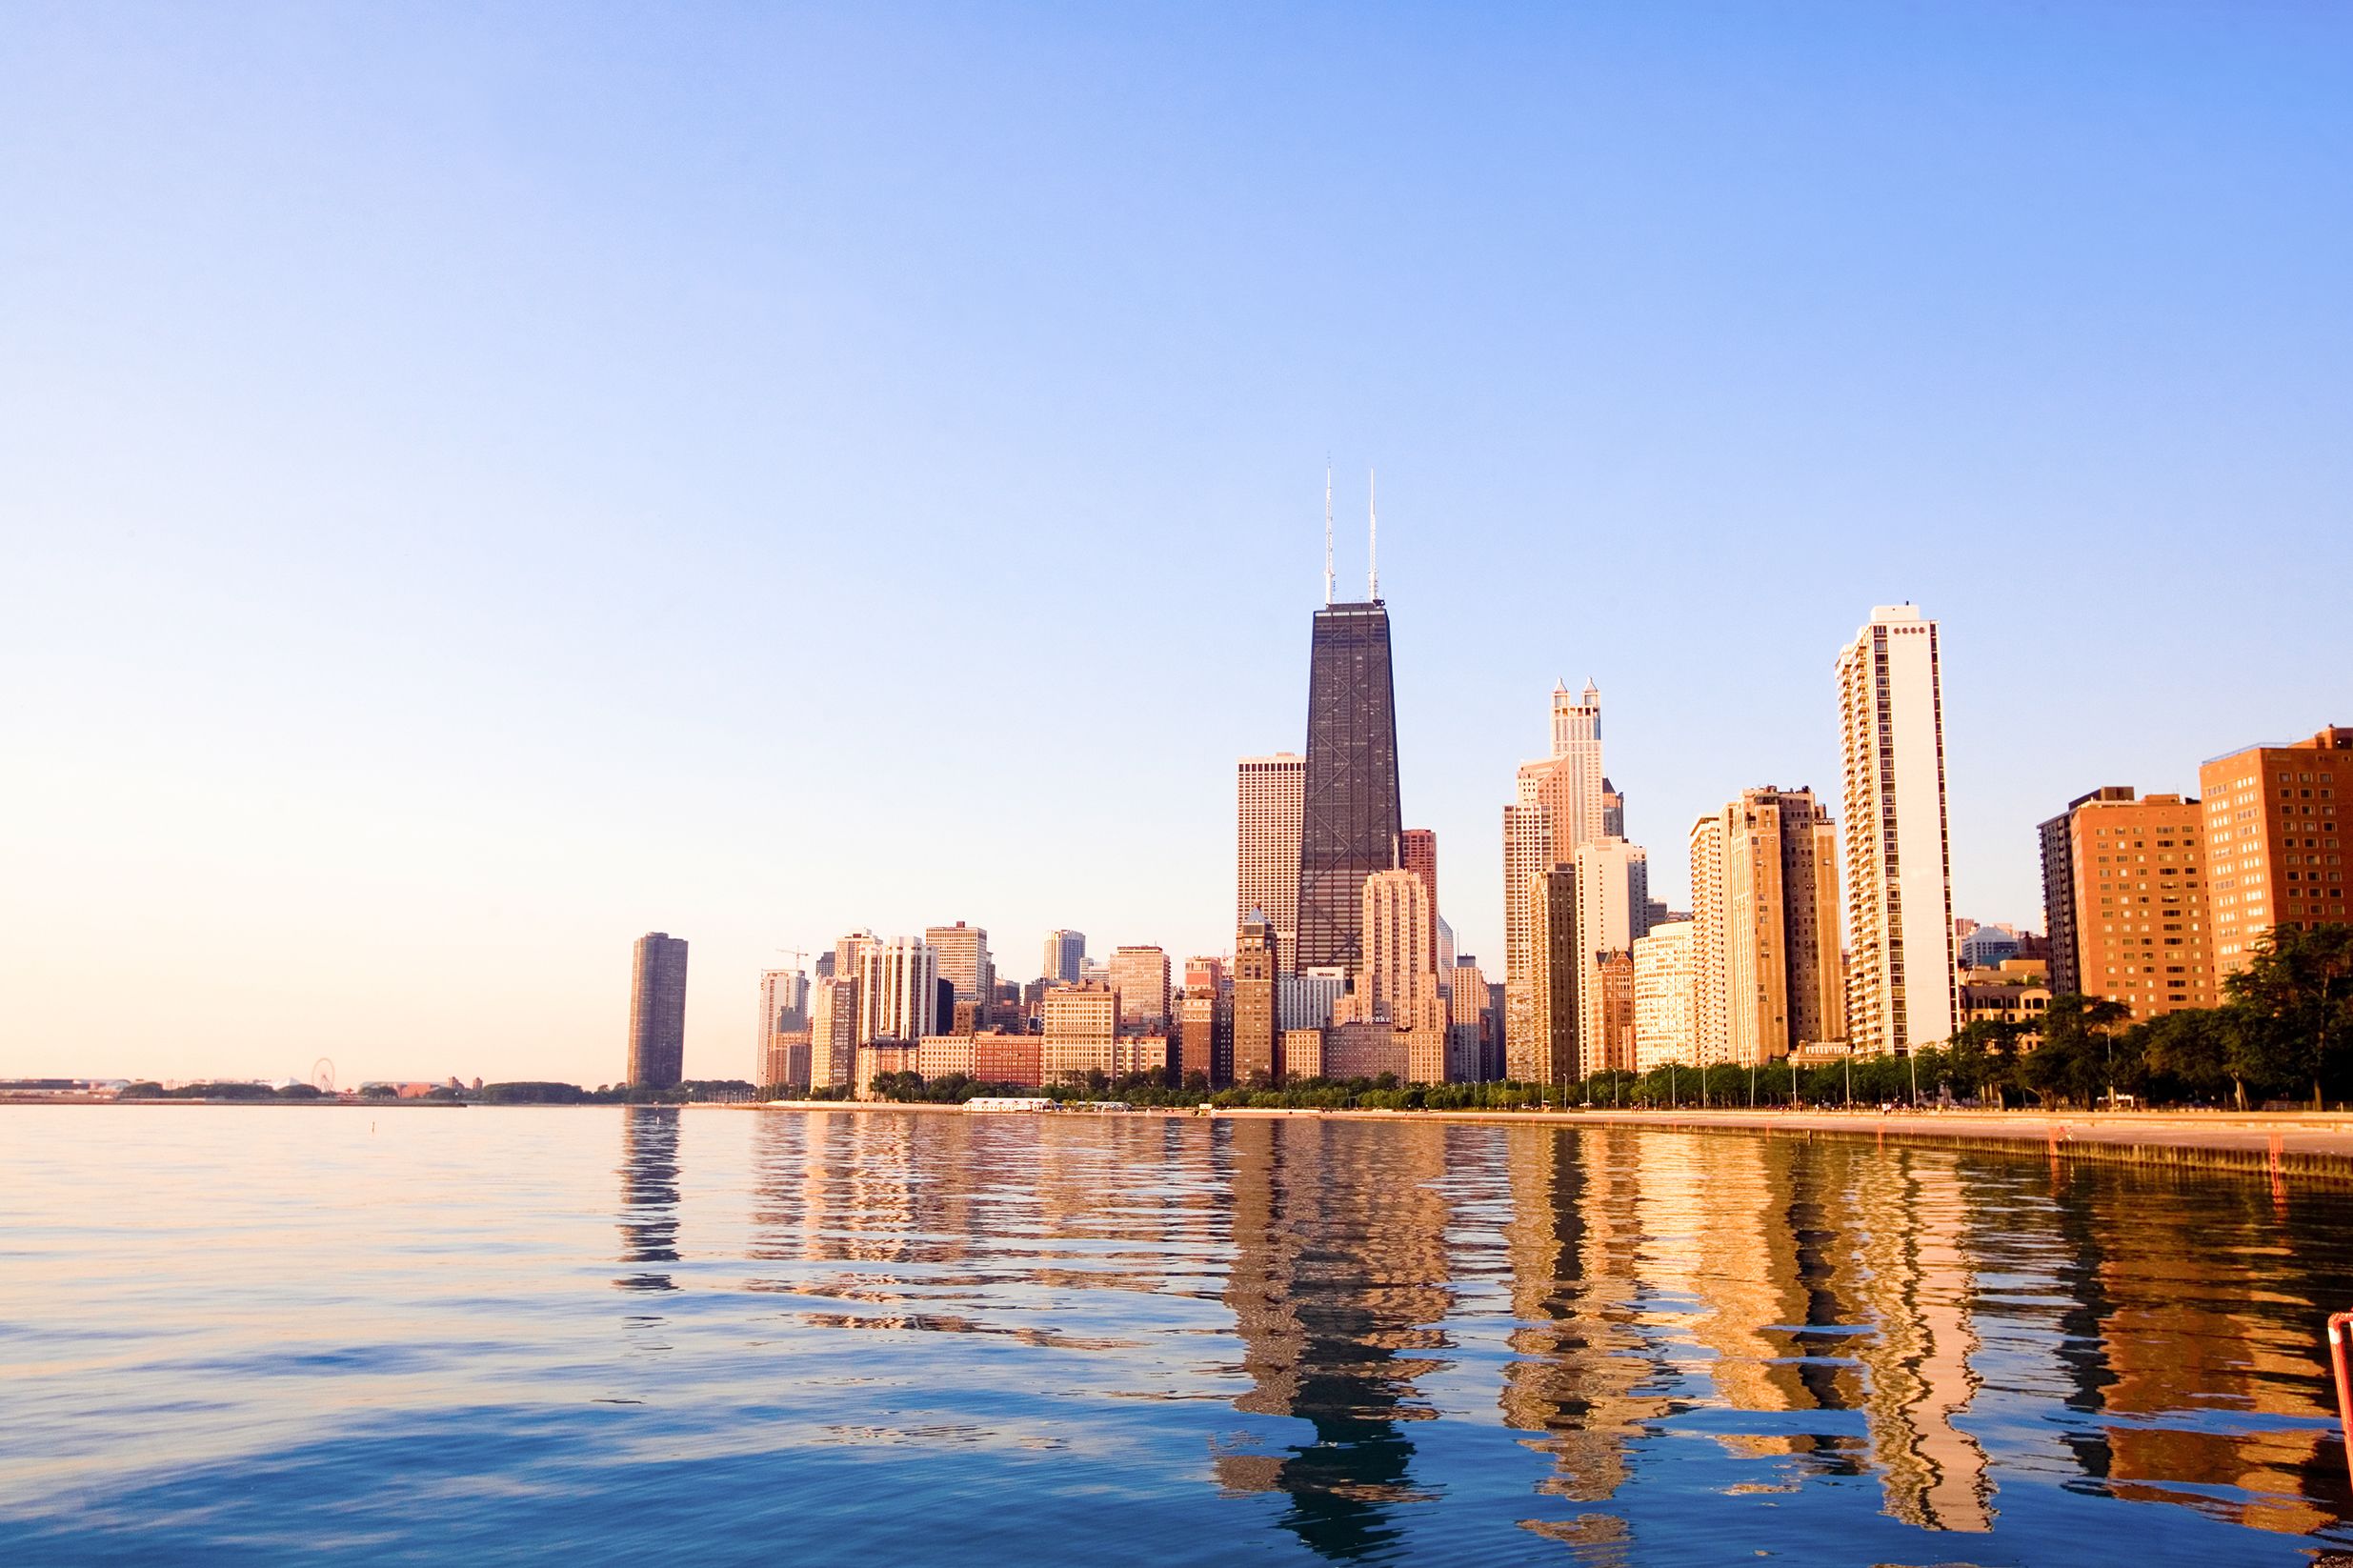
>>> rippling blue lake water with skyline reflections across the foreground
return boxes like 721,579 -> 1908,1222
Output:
0,1107 -> 2353,1568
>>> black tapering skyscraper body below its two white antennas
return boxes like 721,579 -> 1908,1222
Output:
1295,598 -> 1405,970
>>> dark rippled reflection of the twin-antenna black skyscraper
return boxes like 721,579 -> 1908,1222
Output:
1217,1116 -> 1452,1558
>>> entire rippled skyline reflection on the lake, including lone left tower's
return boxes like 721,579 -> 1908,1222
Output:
616,1112 -> 2346,1561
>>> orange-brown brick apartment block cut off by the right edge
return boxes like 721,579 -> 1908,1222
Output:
2198,725 -> 2353,975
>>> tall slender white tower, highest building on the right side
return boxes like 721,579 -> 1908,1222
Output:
1838,605 -> 1958,1055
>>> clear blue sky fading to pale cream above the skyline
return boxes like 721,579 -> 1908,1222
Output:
0,0 -> 2353,1083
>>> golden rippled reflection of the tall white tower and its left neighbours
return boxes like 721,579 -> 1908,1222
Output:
1501,1128 -> 1993,1544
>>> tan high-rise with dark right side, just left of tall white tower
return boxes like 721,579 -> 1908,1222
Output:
1692,786 -> 1847,1064
